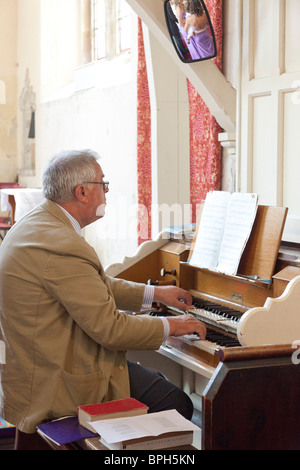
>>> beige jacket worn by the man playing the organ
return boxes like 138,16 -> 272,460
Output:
0,200 -> 163,433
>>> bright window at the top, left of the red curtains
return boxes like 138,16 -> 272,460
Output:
91,0 -> 131,60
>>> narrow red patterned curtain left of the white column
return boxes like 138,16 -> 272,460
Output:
137,19 -> 152,244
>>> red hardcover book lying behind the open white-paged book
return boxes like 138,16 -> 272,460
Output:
77,398 -> 148,432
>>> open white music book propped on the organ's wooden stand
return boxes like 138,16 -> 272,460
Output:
189,191 -> 258,275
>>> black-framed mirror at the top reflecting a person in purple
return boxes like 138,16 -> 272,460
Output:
164,0 -> 217,63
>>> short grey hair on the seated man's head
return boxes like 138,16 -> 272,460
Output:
42,149 -> 100,202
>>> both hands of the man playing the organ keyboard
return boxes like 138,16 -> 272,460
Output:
154,286 -> 206,339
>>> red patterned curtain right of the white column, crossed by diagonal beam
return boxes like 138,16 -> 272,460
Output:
187,0 -> 222,222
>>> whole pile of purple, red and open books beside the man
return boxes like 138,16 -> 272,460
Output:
37,398 -> 199,450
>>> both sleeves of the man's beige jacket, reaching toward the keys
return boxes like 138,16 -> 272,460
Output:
43,253 -> 164,350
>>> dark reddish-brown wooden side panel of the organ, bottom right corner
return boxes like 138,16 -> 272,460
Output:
202,348 -> 300,450
